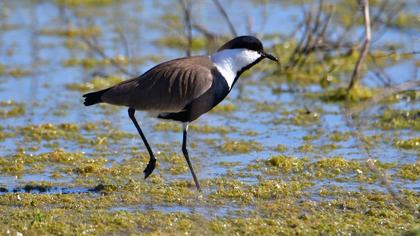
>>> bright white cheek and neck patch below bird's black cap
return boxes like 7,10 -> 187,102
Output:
210,49 -> 261,89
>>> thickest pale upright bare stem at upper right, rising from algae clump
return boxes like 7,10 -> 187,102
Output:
347,0 -> 372,93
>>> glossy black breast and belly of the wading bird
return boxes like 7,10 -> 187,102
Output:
158,68 -> 230,122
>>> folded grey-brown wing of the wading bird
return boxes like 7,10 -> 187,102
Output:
102,56 -> 213,112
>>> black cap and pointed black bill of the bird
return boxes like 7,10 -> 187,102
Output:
217,35 -> 278,62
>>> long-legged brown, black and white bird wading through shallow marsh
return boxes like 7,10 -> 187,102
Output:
83,35 -> 278,191
